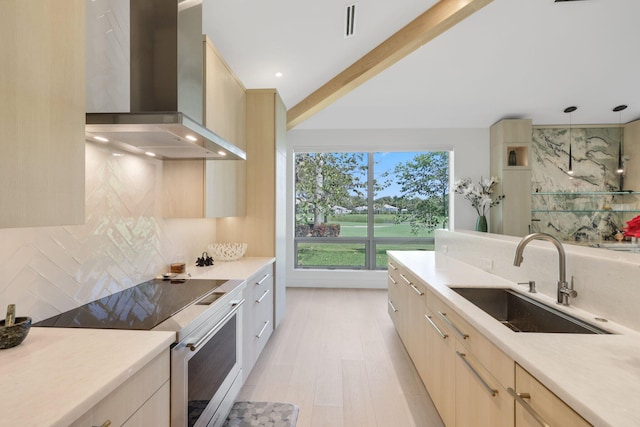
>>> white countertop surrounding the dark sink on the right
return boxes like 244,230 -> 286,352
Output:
389,251 -> 640,427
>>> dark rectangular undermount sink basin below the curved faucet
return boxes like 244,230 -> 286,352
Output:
451,287 -> 610,334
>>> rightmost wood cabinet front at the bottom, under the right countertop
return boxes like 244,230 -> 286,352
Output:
510,364 -> 591,427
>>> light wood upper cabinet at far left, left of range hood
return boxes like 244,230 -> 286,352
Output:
0,0 -> 85,227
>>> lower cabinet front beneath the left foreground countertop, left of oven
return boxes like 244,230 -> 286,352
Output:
71,348 -> 170,427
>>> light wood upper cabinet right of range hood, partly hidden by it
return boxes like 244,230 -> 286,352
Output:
163,36 -> 246,218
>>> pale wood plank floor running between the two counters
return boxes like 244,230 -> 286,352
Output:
238,288 -> 443,427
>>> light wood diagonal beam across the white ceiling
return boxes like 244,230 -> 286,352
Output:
287,0 -> 493,129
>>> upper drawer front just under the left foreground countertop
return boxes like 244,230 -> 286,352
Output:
71,349 -> 170,427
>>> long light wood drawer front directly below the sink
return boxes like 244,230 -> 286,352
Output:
427,291 -> 514,388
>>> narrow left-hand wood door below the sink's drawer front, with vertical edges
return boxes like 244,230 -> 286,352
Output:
421,306 -> 456,426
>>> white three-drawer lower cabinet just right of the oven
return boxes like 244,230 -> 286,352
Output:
242,263 -> 274,379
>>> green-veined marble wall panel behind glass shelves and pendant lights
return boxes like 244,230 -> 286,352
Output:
531,127 -> 640,243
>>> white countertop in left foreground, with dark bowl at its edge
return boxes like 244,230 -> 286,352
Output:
0,327 -> 175,427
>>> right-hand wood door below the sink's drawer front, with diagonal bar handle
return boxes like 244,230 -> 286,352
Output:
455,342 -> 513,427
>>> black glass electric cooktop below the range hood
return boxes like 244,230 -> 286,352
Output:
33,279 -> 227,330
